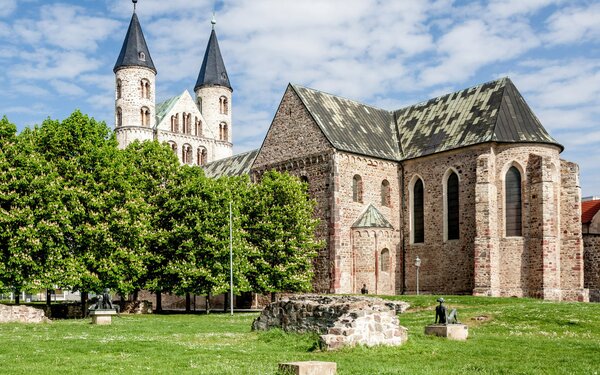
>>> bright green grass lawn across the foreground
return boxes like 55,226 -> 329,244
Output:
0,296 -> 600,375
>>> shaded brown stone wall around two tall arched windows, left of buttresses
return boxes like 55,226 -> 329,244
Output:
402,146 -> 480,294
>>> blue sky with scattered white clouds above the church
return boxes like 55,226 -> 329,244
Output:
0,0 -> 600,196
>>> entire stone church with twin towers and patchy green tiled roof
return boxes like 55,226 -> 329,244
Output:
114,5 -> 589,301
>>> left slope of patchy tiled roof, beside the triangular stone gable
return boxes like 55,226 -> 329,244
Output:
291,85 -> 400,160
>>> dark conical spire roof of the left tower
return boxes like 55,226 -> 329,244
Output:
113,12 -> 156,74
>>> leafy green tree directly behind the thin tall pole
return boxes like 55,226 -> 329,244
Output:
159,166 -> 252,308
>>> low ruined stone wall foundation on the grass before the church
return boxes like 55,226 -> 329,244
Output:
252,295 -> 409,350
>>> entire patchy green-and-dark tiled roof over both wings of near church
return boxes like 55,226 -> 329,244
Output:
292,78 -> 562,160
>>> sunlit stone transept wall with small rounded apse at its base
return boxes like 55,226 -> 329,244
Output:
330,152 -> 400,294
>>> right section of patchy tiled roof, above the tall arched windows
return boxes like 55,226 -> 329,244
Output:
394,78 -> 562,159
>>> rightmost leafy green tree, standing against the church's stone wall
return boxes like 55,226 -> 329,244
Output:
244,171 -> 322,297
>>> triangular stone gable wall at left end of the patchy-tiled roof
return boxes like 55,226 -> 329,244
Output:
253,85 -> 332,168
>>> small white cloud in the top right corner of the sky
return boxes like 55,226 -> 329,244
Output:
544,2 -> 600,44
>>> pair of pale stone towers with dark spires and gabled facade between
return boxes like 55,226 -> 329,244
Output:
113,10 -> 233,165
